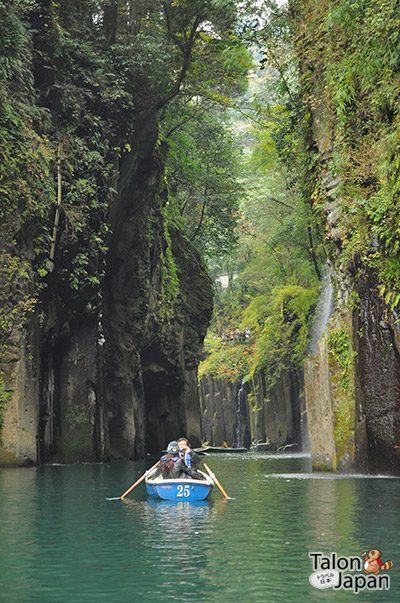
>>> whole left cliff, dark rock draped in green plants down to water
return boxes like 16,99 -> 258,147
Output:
0,1 -> 212,465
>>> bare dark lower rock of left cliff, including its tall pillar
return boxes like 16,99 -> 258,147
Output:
0,115 -> 213,464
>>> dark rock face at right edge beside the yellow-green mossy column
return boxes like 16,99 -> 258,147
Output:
355,276 -> 400,473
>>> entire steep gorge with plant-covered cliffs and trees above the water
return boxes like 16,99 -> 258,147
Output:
0,0 -> 400,474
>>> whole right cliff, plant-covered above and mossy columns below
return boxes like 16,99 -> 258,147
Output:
290,0 -> 400,473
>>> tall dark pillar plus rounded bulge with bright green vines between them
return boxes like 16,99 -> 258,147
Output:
104,117 -> 212,458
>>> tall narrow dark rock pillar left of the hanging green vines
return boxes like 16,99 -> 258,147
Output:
103,117 -> 162,458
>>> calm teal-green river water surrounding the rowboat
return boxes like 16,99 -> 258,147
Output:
0,452 -> 400,603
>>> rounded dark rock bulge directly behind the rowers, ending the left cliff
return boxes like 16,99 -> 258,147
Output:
141,231 -> 213,452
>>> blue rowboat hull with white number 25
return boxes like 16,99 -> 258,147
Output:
146,471 -> 214,501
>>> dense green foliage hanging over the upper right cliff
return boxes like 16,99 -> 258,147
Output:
297,0 -> 400,308
